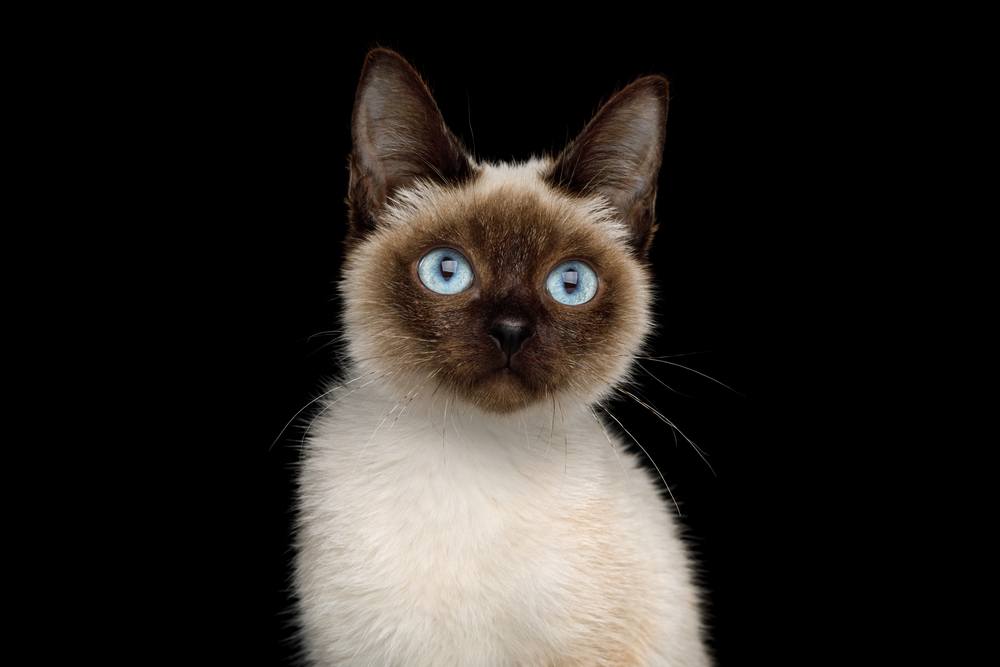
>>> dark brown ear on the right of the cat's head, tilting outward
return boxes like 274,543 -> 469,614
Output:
547,76 -> 668,256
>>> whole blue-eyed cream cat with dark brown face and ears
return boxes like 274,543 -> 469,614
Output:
295,49 -> 710,667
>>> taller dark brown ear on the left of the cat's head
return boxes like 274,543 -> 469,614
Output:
348,49 -> 474,239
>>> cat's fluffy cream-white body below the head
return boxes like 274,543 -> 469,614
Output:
298,376 -> 708,667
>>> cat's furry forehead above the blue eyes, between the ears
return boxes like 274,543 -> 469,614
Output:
383,160 -> 628,265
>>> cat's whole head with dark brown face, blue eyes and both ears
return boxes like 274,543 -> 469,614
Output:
341,49 -> 667,413
